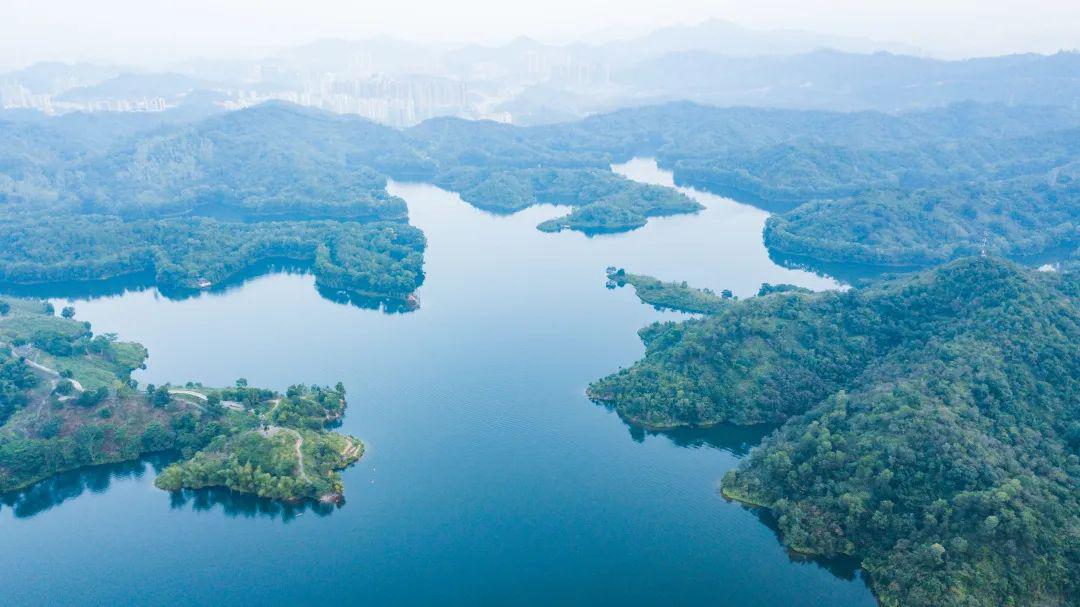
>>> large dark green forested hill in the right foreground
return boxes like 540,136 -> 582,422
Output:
590,257 -> 1080,606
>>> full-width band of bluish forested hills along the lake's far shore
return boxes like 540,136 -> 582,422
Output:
6,103 -> 1080,297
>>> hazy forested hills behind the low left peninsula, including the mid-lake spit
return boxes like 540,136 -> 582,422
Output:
0,103 -> 701,231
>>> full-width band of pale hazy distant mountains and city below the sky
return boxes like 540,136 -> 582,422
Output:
0,19 -> 1080,126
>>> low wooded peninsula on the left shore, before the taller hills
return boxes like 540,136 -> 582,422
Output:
0,215 -> 426,297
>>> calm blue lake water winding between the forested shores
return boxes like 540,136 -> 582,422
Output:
0,160 -> 874,607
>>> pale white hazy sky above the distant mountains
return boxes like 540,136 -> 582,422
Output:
0,0 -> 1080,67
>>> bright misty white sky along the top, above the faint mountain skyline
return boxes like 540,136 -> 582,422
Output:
6,0 -> 1080,70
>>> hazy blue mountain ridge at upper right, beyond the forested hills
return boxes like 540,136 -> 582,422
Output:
591,51 -> 1080,111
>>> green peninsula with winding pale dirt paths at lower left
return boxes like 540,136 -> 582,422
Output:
0,299 -> 364,501
